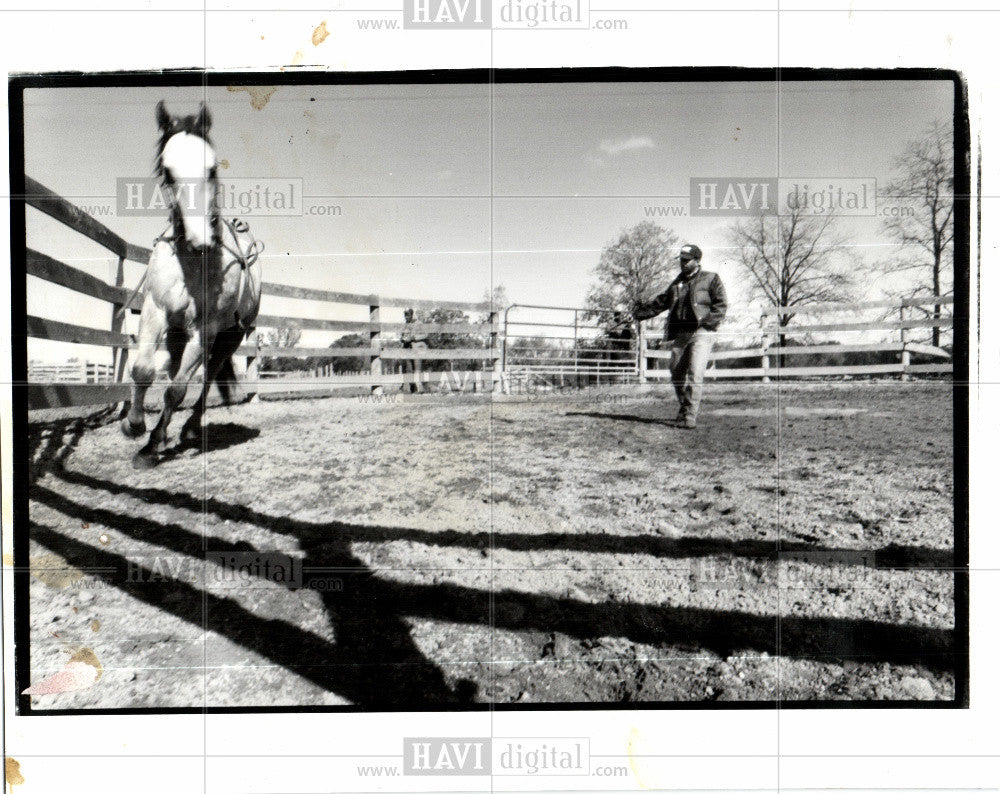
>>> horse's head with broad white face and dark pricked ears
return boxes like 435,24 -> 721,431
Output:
156,101 -> 219,252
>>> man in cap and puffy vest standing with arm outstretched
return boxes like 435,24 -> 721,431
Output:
635,244 -> 727,428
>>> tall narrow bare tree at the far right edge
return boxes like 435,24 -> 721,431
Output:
883,121 -> 955,347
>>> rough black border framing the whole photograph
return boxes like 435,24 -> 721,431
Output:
0,66 -> 978,716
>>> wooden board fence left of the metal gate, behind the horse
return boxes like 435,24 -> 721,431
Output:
25,176 -> 501,409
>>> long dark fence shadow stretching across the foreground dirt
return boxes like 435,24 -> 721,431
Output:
25,426 -> 955,708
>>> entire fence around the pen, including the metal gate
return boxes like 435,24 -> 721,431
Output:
24,176 -> 954,409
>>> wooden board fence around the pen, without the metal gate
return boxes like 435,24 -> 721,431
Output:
25,172 -> 953,409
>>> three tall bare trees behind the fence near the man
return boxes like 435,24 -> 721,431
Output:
587,121 -> 955,346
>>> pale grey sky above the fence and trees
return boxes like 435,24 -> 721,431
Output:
19,81 -> 952,361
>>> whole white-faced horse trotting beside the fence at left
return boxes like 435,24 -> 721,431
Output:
122,102 -> 263,468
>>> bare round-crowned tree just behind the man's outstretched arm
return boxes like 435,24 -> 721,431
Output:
586,221 -> 680,317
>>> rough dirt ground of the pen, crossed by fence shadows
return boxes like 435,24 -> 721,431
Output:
23,382 -> 956,709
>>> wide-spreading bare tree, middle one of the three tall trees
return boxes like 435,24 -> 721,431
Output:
730,207 -> 853,334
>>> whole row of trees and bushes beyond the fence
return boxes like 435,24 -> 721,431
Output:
261,121 -> 955,374
